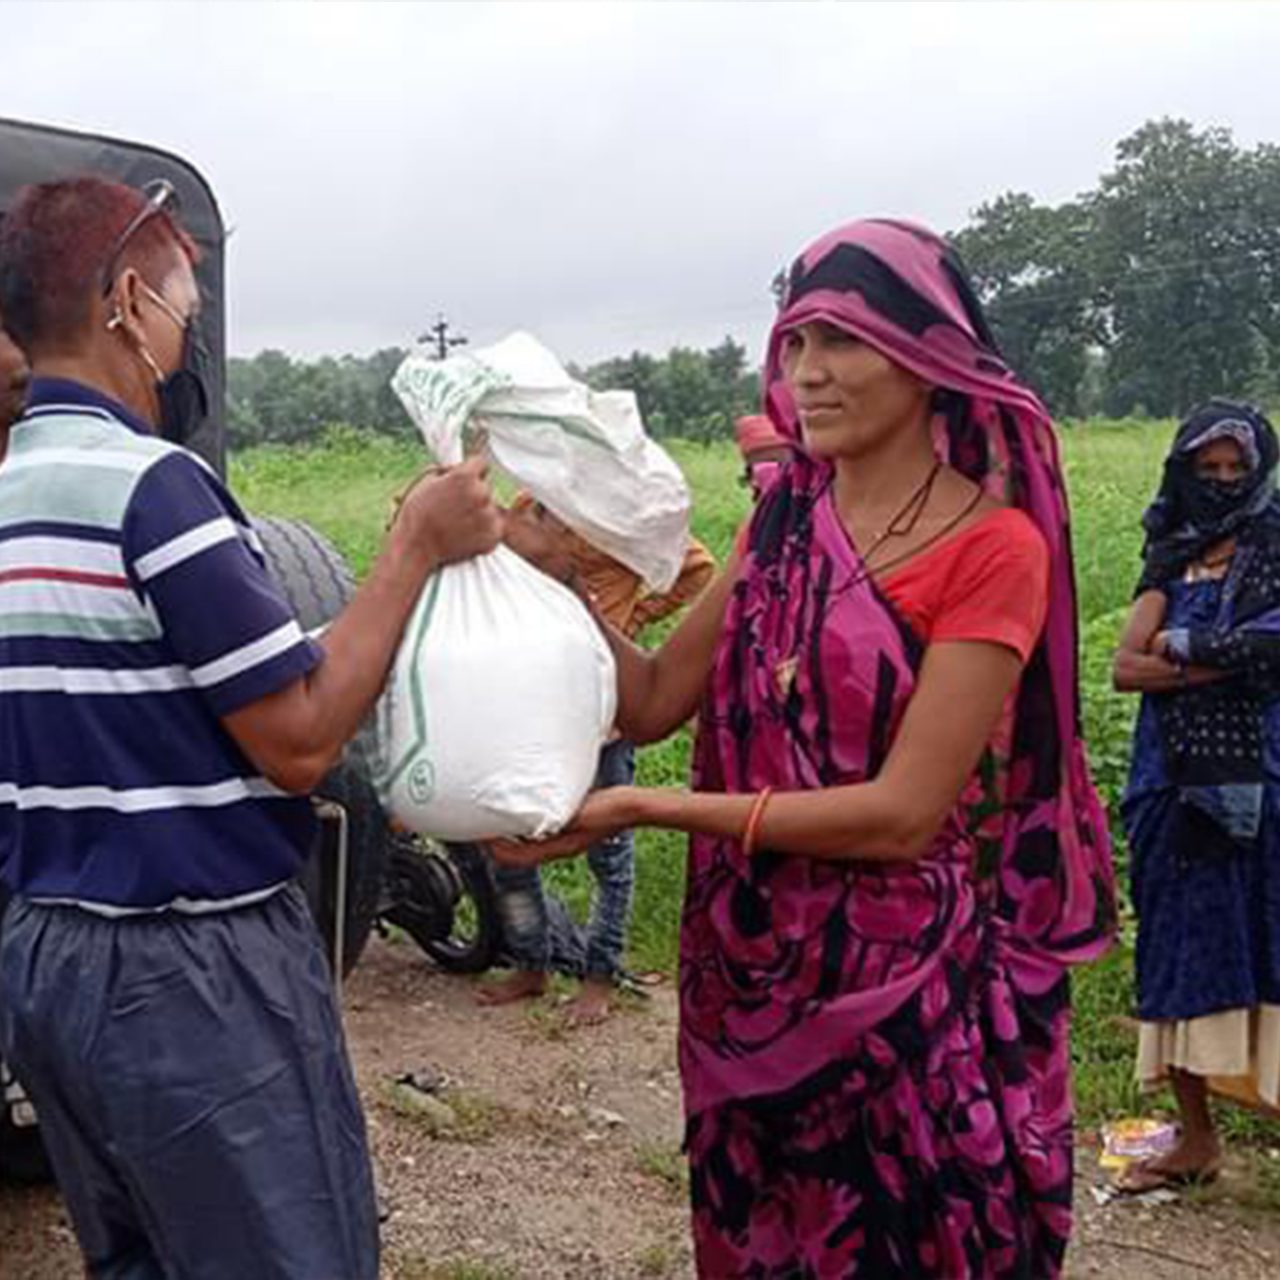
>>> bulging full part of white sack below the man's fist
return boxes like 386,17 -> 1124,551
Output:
376,547 -> 617,841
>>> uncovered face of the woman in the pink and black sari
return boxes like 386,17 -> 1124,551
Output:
781,320 -> 929,458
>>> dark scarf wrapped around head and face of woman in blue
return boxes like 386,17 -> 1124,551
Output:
1138,399 -> 1280,591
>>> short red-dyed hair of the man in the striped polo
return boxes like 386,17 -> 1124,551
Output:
0,177 -> 200,352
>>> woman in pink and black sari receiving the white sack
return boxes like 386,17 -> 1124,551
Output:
498,220 -> 1114,1280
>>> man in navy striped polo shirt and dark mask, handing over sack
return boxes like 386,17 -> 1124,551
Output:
0,179 -> 500,1280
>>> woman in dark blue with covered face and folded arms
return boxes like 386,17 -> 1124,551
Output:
1115,401 -> 1280,1190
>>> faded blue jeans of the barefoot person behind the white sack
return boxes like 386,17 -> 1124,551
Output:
494,741 -> 635,979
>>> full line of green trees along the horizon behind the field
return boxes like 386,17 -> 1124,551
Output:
228,119 -> 1280,447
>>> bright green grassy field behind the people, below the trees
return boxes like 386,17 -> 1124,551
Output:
232,422 -> 1280,1146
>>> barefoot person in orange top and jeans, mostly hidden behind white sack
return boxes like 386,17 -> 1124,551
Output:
477,494 -> 716,1025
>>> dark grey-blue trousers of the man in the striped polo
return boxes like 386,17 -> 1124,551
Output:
0,888 -> 378,1280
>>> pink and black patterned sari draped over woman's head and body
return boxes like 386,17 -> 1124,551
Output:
680,223 -> 1114,1280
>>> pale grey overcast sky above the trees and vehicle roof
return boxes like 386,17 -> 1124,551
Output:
0,0 -> 1280,360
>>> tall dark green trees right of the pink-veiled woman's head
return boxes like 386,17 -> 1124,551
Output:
952,119 -> 1280,416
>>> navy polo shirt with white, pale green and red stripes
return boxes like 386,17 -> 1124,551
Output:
0,379 -> 321,914
